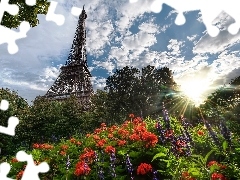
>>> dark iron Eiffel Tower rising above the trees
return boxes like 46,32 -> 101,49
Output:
44,6 -> 93,110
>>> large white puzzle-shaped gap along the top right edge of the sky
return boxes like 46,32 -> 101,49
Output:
129,0 -> 240,37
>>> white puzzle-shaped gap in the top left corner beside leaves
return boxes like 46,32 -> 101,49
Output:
0,0 -> 19,22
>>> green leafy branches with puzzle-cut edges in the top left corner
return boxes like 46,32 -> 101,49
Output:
1,0 -> 50,28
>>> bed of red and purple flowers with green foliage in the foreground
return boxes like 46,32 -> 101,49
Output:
5,105 -> 240,180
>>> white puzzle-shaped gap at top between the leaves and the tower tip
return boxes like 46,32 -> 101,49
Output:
46,1 -> 65,26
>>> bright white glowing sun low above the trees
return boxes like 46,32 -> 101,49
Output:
180,78 -> 209,106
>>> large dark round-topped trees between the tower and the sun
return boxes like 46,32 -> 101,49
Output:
105,65 -> 176,121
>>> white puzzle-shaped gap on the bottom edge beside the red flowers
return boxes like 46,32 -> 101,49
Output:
16,151 -> 49,180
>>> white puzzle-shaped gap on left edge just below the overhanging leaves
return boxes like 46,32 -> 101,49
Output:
0,21 -> 30,54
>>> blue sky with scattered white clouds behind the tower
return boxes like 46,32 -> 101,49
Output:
0,0 -> 240,103
